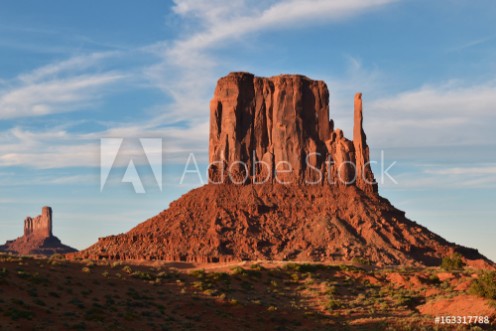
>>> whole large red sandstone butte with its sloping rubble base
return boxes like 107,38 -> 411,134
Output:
75,73 -> 493,266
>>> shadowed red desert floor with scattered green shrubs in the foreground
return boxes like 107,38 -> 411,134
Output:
0,254 -> 496,330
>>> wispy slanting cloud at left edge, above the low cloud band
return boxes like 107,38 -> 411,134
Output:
0,51 -> 126,119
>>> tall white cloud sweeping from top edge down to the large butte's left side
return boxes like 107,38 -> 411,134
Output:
146,0 -> 397,122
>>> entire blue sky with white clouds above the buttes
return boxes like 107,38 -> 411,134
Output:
0,0 -> 496,260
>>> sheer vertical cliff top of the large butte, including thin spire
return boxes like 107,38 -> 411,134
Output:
209,73 -> 377,193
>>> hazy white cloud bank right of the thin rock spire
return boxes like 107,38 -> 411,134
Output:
364,81 -> 496,148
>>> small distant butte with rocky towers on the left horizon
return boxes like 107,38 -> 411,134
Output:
0,207 -> 77,255
